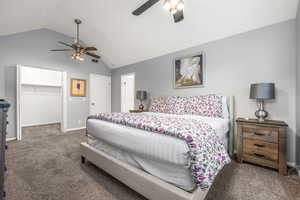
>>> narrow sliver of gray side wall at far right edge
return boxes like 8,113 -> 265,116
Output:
296,3 -> 300,166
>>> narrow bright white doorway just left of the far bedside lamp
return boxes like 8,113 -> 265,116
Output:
121,73 -> 135,112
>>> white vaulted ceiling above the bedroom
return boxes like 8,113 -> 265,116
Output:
0,0 -> 298,68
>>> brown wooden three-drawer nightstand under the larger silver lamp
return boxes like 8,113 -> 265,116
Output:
236,118 -> 288,175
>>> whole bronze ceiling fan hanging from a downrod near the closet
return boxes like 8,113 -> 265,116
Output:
50,19 -> 100,61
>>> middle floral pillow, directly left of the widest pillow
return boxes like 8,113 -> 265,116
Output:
165,96 -> 185,115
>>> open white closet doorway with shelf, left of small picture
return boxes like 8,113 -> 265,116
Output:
17,66 -> 67,140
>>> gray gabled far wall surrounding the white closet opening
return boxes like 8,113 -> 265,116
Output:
0,29 -> 110,137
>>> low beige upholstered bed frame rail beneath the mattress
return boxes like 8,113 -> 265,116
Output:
80,142 -> 208,200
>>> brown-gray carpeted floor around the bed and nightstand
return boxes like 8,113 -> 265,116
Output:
6,125 -> 300,200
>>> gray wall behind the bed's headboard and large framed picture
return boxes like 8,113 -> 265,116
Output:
112,20 -> 296,162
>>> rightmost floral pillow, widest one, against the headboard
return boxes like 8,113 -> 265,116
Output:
185,94 -> 224,118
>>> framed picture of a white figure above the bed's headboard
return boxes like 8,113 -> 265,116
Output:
172,52 -> 206,89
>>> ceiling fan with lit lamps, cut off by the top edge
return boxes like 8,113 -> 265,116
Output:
132,0 -> 184,23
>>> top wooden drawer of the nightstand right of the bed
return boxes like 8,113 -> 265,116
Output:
242,126 -> 278,143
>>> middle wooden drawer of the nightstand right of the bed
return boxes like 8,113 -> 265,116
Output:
243,139 -> 278,161
